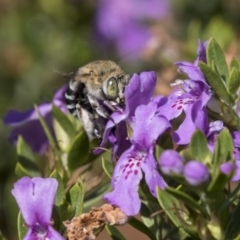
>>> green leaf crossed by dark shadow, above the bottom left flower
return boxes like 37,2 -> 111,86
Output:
15,136 -> 40,177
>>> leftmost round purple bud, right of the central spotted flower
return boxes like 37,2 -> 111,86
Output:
159,150 -> 184,175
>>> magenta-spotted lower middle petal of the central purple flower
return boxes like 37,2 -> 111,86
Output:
103,148 -> 142,216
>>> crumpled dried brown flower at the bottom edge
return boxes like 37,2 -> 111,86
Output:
63,204 -> 128,240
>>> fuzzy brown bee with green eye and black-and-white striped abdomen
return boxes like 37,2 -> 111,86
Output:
65,60 -> 130,140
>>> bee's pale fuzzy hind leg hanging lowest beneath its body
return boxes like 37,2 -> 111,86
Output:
76,104 -> 101,141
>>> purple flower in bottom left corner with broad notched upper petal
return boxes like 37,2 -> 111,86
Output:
12,177 -> 63,240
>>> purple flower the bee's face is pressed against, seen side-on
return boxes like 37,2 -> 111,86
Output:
94,72 -> 157,156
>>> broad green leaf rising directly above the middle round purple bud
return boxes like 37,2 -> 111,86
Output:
190,130 -> 212,164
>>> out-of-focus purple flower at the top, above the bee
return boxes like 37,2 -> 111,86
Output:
96,0 -> 170,57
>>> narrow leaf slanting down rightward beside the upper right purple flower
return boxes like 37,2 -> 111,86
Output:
199,62 -> 234,104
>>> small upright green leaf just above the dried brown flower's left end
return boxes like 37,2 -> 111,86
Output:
69,183 -> 84,217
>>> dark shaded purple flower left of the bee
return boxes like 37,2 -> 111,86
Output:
4,86 -> 67,154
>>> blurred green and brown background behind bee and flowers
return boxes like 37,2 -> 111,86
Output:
0,0 -> 240,239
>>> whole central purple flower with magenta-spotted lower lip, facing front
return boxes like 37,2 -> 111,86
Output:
104,102 -> 170,216
